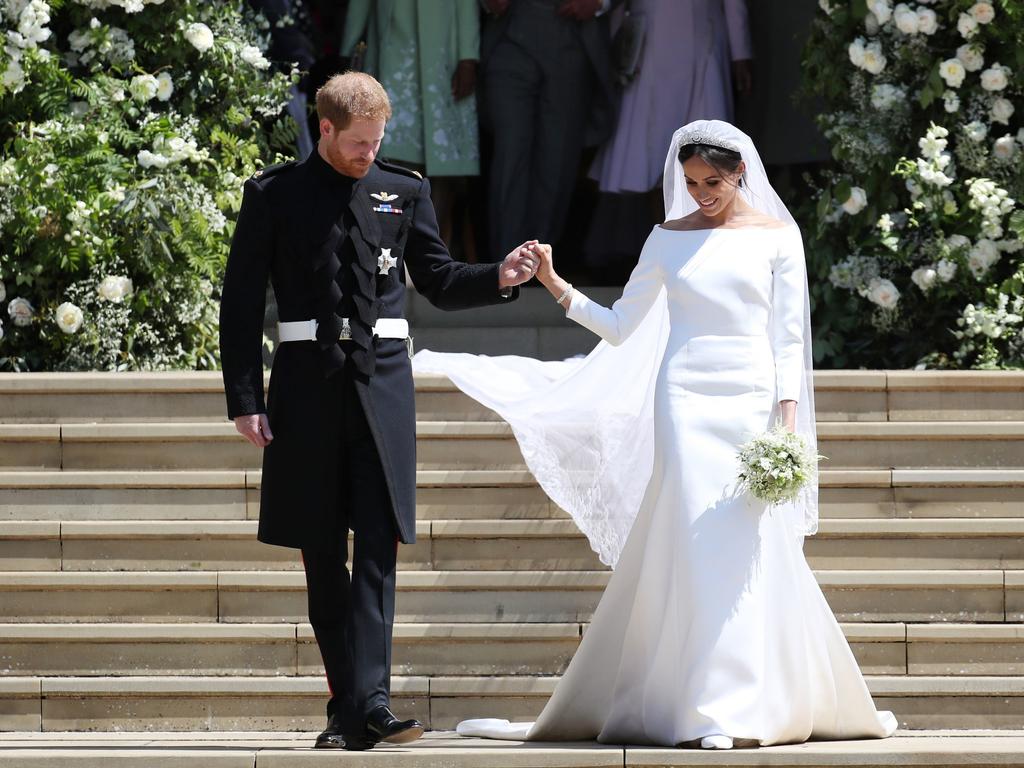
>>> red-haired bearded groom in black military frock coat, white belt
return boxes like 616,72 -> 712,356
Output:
220,73 -> 539,750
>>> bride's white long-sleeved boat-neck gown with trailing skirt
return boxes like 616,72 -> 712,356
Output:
459,225 -> 896,745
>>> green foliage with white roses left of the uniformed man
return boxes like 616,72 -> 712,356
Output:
0,0 -> 295,371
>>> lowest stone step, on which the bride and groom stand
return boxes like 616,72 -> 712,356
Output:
0,727 -> 1024,768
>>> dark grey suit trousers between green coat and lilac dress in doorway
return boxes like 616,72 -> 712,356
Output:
482,0 -> 597,260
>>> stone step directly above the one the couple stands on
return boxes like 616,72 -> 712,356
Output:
0,675 -> 1024,731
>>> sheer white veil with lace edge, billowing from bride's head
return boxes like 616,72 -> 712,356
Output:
413,120 -> 817,566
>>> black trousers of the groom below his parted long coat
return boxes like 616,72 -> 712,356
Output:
302,367 -> 398,734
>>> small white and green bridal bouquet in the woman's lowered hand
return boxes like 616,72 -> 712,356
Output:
738,424 -> 823,504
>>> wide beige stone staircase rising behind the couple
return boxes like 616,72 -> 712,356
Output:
0,372 -> 1024,749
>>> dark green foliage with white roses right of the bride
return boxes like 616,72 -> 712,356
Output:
801,0 -> 1024,368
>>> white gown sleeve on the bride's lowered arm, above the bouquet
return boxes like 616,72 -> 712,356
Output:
770,227 -> 809,400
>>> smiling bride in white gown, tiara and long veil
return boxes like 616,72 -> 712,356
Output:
416,121 -> 896,749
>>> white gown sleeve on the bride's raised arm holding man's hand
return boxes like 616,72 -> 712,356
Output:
565,231 -> 665,346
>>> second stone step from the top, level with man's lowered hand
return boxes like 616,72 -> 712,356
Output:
6,421 -> 1024,470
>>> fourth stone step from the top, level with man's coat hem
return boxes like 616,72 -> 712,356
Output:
0,518 -> 1024,571
